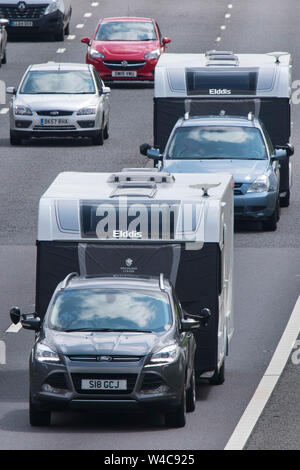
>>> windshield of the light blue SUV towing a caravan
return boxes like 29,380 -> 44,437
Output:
167,126 -> 268,160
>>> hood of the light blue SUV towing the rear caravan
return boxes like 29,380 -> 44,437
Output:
163,160 -> 269,183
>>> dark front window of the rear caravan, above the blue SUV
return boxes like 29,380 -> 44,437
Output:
186,68 -> 258,96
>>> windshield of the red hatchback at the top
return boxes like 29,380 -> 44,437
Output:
95,21 -> 157,41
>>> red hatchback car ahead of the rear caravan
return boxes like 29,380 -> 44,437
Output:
81,17 -> 171,82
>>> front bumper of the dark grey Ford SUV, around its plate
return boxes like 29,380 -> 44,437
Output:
30,360 -> 185,411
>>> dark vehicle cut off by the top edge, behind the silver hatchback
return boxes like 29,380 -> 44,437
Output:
0,0 -> 72,41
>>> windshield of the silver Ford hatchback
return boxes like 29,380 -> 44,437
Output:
20,70 -> 95,95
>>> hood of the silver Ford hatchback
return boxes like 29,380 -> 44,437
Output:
14,94 -> 97,111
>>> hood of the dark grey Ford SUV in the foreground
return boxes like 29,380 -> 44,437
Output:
51,332 -> 161,356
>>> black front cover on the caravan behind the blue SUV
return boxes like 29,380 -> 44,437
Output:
154,96 -> 291,152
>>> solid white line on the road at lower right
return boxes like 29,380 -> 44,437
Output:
225,297 -> 300,450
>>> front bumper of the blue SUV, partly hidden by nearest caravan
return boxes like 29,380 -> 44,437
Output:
234,191 -> 278,221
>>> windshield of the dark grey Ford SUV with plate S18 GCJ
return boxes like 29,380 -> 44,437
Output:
49,289 -> 172,332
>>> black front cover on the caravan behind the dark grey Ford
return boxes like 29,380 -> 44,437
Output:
36,242 -> 221,371
